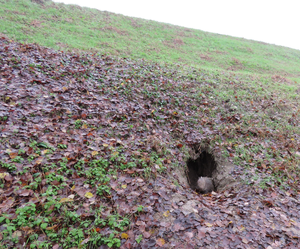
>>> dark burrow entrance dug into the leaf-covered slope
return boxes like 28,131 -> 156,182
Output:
186,146 -> 235,192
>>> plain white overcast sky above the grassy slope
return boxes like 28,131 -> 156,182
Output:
54,0 -> 300,50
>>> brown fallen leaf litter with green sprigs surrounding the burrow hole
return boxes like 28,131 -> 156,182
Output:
0,37 -> 300,248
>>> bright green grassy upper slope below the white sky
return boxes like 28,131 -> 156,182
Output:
0,0 -> 300,80
